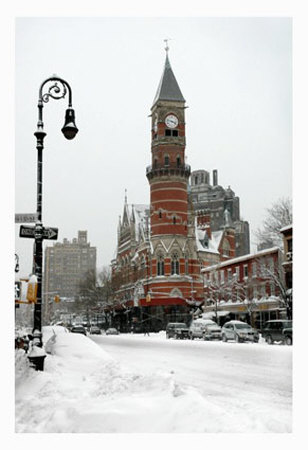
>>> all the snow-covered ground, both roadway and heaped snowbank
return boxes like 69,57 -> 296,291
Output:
16,327 -> 292,433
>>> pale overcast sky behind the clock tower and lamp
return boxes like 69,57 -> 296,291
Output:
15,17 -> 292,276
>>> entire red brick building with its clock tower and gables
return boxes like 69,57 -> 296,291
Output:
112,49 -> 235,330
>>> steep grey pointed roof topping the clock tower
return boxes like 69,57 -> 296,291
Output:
153,54 -> 185,106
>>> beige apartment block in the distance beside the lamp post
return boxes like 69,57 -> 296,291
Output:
44,231 -> 96,306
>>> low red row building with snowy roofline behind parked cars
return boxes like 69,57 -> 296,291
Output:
202,247 -> 287,328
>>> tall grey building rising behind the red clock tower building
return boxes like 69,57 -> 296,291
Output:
190,170 -> 250,256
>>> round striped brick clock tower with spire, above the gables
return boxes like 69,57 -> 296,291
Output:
147,47 -> 190,237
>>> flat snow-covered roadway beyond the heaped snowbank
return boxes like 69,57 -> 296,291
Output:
92,333 -> 292,432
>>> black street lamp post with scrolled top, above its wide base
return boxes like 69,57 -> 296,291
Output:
33,76 -> 78,332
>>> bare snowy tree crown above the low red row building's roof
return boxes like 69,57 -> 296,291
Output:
255,198 -> 293,248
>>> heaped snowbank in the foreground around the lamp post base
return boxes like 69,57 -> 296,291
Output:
15,327 -> 244,433
